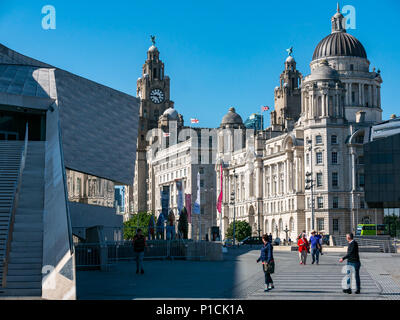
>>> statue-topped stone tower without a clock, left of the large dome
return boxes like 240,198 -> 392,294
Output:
271,49 -> 302,129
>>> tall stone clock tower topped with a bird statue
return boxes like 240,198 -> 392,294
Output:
129,36 -> 174,213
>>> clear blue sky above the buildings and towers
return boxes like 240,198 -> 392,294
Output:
0,0 -> 400,127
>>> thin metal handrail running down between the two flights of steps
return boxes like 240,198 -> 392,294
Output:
2,122 -> 29,288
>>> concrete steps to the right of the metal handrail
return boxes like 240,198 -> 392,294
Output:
2,141 -> 45,297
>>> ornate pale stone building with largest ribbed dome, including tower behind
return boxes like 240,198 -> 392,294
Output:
216,6 -> 383,239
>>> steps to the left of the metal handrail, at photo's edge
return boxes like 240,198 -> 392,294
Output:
0,140 -> 23,293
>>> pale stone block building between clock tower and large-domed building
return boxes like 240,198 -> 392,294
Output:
147,119 -> 216,239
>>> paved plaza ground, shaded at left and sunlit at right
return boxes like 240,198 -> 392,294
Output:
77,248 -> 400,300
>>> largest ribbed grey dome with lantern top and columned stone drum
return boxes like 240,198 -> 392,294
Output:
310,6 -> 382,123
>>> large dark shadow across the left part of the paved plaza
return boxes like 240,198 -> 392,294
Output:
76,246 -> 261,300
